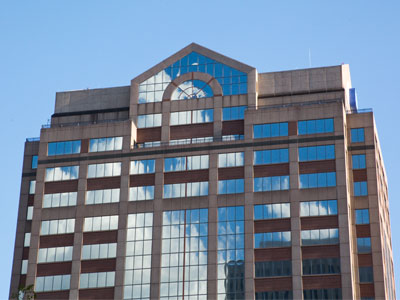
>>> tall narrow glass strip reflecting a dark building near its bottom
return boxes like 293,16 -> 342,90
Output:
217,206 -> 245,299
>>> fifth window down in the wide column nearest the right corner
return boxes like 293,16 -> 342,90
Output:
301,228 -> 339,246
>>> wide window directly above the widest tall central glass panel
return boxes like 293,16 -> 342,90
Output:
163,181 -> 208,199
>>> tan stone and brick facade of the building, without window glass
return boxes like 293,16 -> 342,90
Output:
10,44 -> 395,299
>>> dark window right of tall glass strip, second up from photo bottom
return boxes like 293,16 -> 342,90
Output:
254,260 -> 292,278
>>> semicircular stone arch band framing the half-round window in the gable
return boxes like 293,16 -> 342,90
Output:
162,72 -> 222,101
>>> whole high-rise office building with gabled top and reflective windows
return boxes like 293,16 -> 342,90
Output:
10,44 -> 395,299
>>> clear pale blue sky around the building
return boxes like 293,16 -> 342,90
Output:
0,0 -> 400,299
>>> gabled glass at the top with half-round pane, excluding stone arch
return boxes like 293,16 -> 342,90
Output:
139,52 -> 247,103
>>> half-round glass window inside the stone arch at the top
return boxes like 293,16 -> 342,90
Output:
171,79 -> 213,100
